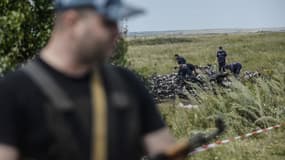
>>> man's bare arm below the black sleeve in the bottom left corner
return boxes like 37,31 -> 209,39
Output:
0,144 -> 19,160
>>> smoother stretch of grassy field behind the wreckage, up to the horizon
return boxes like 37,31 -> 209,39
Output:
128,32 -> 285,75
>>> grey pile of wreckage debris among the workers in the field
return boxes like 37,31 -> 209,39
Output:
147,66 -> 261,102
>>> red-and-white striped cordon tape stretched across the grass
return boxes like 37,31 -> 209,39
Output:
188,124 -> 285,156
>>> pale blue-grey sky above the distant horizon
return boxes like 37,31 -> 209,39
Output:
125,0 -> 285,32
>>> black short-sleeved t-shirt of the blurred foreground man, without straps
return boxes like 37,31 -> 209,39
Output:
0,59 -> 164,160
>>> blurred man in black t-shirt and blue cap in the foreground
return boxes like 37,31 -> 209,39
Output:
0,0 -> 178,160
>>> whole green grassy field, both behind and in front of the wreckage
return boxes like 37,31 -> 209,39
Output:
128,32 -> 285,160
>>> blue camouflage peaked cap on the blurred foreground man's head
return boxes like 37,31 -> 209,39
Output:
54,0 -> 144,21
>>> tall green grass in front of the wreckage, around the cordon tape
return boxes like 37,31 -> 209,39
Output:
160,65 -> 285,160
